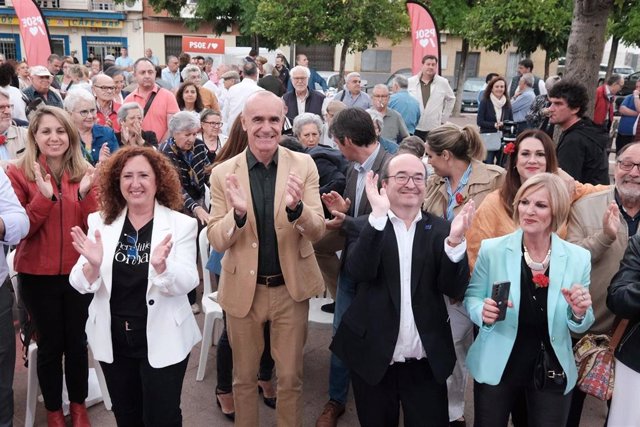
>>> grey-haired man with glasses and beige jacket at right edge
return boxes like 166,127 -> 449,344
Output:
567,142 -> 640,427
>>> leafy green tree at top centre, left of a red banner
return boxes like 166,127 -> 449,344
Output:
252,0 -> 409,87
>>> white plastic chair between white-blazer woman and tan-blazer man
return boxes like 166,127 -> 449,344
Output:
196,227 -> 224,381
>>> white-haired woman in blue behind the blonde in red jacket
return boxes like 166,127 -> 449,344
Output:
64,89 -> 118,165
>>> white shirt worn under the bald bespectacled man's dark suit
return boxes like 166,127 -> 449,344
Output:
369,210 -> 467,364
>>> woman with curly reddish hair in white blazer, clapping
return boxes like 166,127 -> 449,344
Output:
70,147 -> 201,426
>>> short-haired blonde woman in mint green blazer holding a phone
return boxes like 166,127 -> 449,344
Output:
464,173 -> 594,426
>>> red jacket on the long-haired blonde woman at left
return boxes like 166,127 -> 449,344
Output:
7,165 -> 98,276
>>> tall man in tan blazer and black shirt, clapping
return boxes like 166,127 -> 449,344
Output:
208,91 -> 325,427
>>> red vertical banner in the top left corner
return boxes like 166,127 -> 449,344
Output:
13,0 -> 51,66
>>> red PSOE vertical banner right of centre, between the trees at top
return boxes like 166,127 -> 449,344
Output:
407,1 -> 441,74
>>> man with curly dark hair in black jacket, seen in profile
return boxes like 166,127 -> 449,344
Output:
548,80 -> 609,185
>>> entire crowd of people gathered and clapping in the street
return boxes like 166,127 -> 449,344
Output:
0,48 -> 640,427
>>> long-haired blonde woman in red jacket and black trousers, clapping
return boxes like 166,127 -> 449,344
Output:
7,106 -> 97,427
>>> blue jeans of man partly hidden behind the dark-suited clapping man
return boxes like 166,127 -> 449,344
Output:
329,271 -> 356,405
